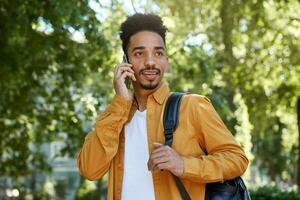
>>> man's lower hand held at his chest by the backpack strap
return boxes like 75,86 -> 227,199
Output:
148,143 -> 184,176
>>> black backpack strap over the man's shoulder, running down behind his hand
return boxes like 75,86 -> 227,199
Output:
163,92 -> 191,200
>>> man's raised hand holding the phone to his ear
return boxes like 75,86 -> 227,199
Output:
114,63 -> 136,100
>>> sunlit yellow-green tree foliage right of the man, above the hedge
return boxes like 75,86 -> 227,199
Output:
156,0 -> 300,182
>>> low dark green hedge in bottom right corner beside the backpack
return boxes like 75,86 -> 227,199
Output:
250,186 -> 300,200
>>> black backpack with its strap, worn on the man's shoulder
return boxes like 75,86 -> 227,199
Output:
163,92 -> 251,200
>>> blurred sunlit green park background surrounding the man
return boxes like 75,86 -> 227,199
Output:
0,0 -> 300,200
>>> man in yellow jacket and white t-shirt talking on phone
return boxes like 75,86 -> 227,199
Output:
78,14 -> 248,200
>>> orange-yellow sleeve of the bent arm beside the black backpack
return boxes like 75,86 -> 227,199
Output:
181,96 -> 248,183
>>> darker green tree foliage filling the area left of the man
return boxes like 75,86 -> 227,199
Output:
0,0 -> 111,176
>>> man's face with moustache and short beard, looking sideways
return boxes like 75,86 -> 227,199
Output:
127,31 -> 169,90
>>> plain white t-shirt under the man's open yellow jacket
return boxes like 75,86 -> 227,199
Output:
121,110 -> 155,200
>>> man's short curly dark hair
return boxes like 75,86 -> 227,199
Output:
120,13 -> 168,55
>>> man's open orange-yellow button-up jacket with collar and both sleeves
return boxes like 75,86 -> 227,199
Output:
77,85 -> 248,200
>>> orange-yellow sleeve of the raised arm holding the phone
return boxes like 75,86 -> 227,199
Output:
77,95 -> 132,180
